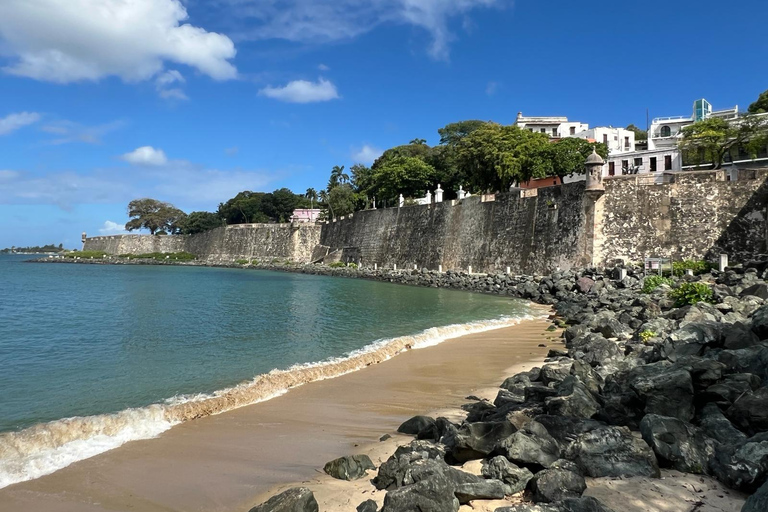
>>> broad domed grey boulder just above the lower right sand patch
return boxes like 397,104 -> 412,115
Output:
565,426 -> 659,478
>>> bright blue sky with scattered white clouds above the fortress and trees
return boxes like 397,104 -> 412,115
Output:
0,0 -> 768,248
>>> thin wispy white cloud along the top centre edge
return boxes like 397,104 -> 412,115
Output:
219,0 -> 504,60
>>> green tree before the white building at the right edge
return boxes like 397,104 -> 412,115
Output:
680,115 -> 768,169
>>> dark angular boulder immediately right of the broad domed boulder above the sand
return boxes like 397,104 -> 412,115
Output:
640,414 -> 715,474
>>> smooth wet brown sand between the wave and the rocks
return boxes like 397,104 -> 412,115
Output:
0,320 -> 561,512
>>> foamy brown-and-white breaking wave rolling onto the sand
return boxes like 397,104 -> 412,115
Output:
0,316 -> 535,488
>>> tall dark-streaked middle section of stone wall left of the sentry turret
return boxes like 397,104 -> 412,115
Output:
321,182 -> 586,273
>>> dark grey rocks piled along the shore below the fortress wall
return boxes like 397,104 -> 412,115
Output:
33,259 -> 768,512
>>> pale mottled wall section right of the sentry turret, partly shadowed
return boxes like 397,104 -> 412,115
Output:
596,169 -> 768,263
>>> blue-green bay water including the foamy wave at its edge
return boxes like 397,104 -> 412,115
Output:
0,255 -> 533,487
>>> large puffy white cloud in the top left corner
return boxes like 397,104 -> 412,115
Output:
0,0 -> 237,83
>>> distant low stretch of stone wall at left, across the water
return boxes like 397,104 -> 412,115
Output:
83,224 -> 321,262
